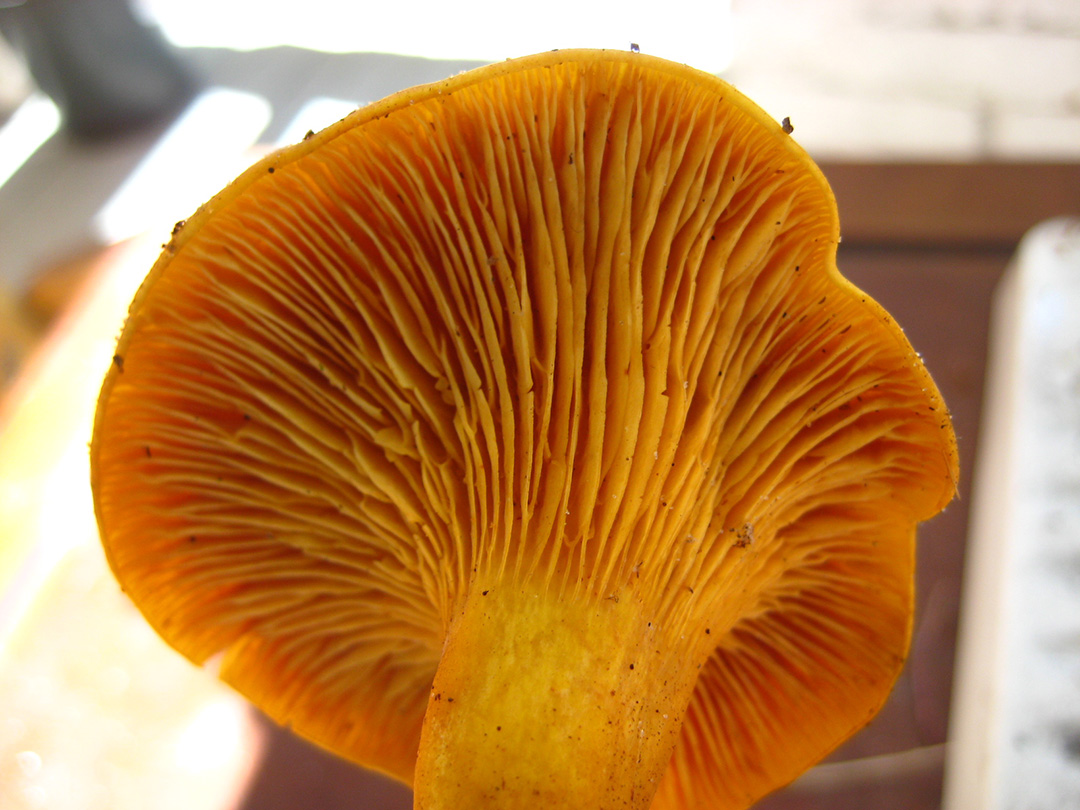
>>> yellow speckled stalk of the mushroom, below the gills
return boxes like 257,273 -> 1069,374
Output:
414,590 -> 698,810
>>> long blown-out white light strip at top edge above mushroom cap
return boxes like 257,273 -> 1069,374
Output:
140,0 -> 732,72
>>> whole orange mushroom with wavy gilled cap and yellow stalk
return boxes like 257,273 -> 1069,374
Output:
92,51 -> 957,810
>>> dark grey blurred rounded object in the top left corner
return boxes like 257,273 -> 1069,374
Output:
0,0 -> 197,140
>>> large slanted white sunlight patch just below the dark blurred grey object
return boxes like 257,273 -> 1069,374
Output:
93,87 -> 272,244
